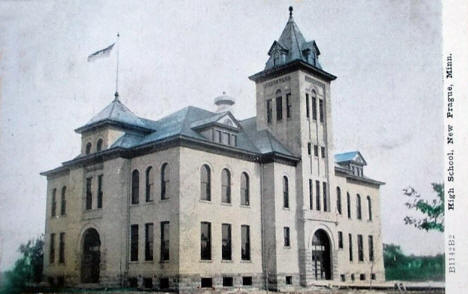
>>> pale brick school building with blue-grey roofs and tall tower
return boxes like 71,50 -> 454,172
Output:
43,10 -> 384,291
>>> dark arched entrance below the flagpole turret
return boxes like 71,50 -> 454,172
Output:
81,228 -> 101,283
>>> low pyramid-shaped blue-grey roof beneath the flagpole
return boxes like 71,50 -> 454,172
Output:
75,93 -> 152,133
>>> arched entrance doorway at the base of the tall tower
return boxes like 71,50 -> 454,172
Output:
312,230 -> 331,280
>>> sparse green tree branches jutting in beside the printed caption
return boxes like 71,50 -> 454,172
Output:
403,183 -> 444,232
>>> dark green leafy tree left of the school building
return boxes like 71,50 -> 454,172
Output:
0,235 -> 44,294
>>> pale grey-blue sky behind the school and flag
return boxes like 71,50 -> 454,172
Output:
0,0 -> 444,270
